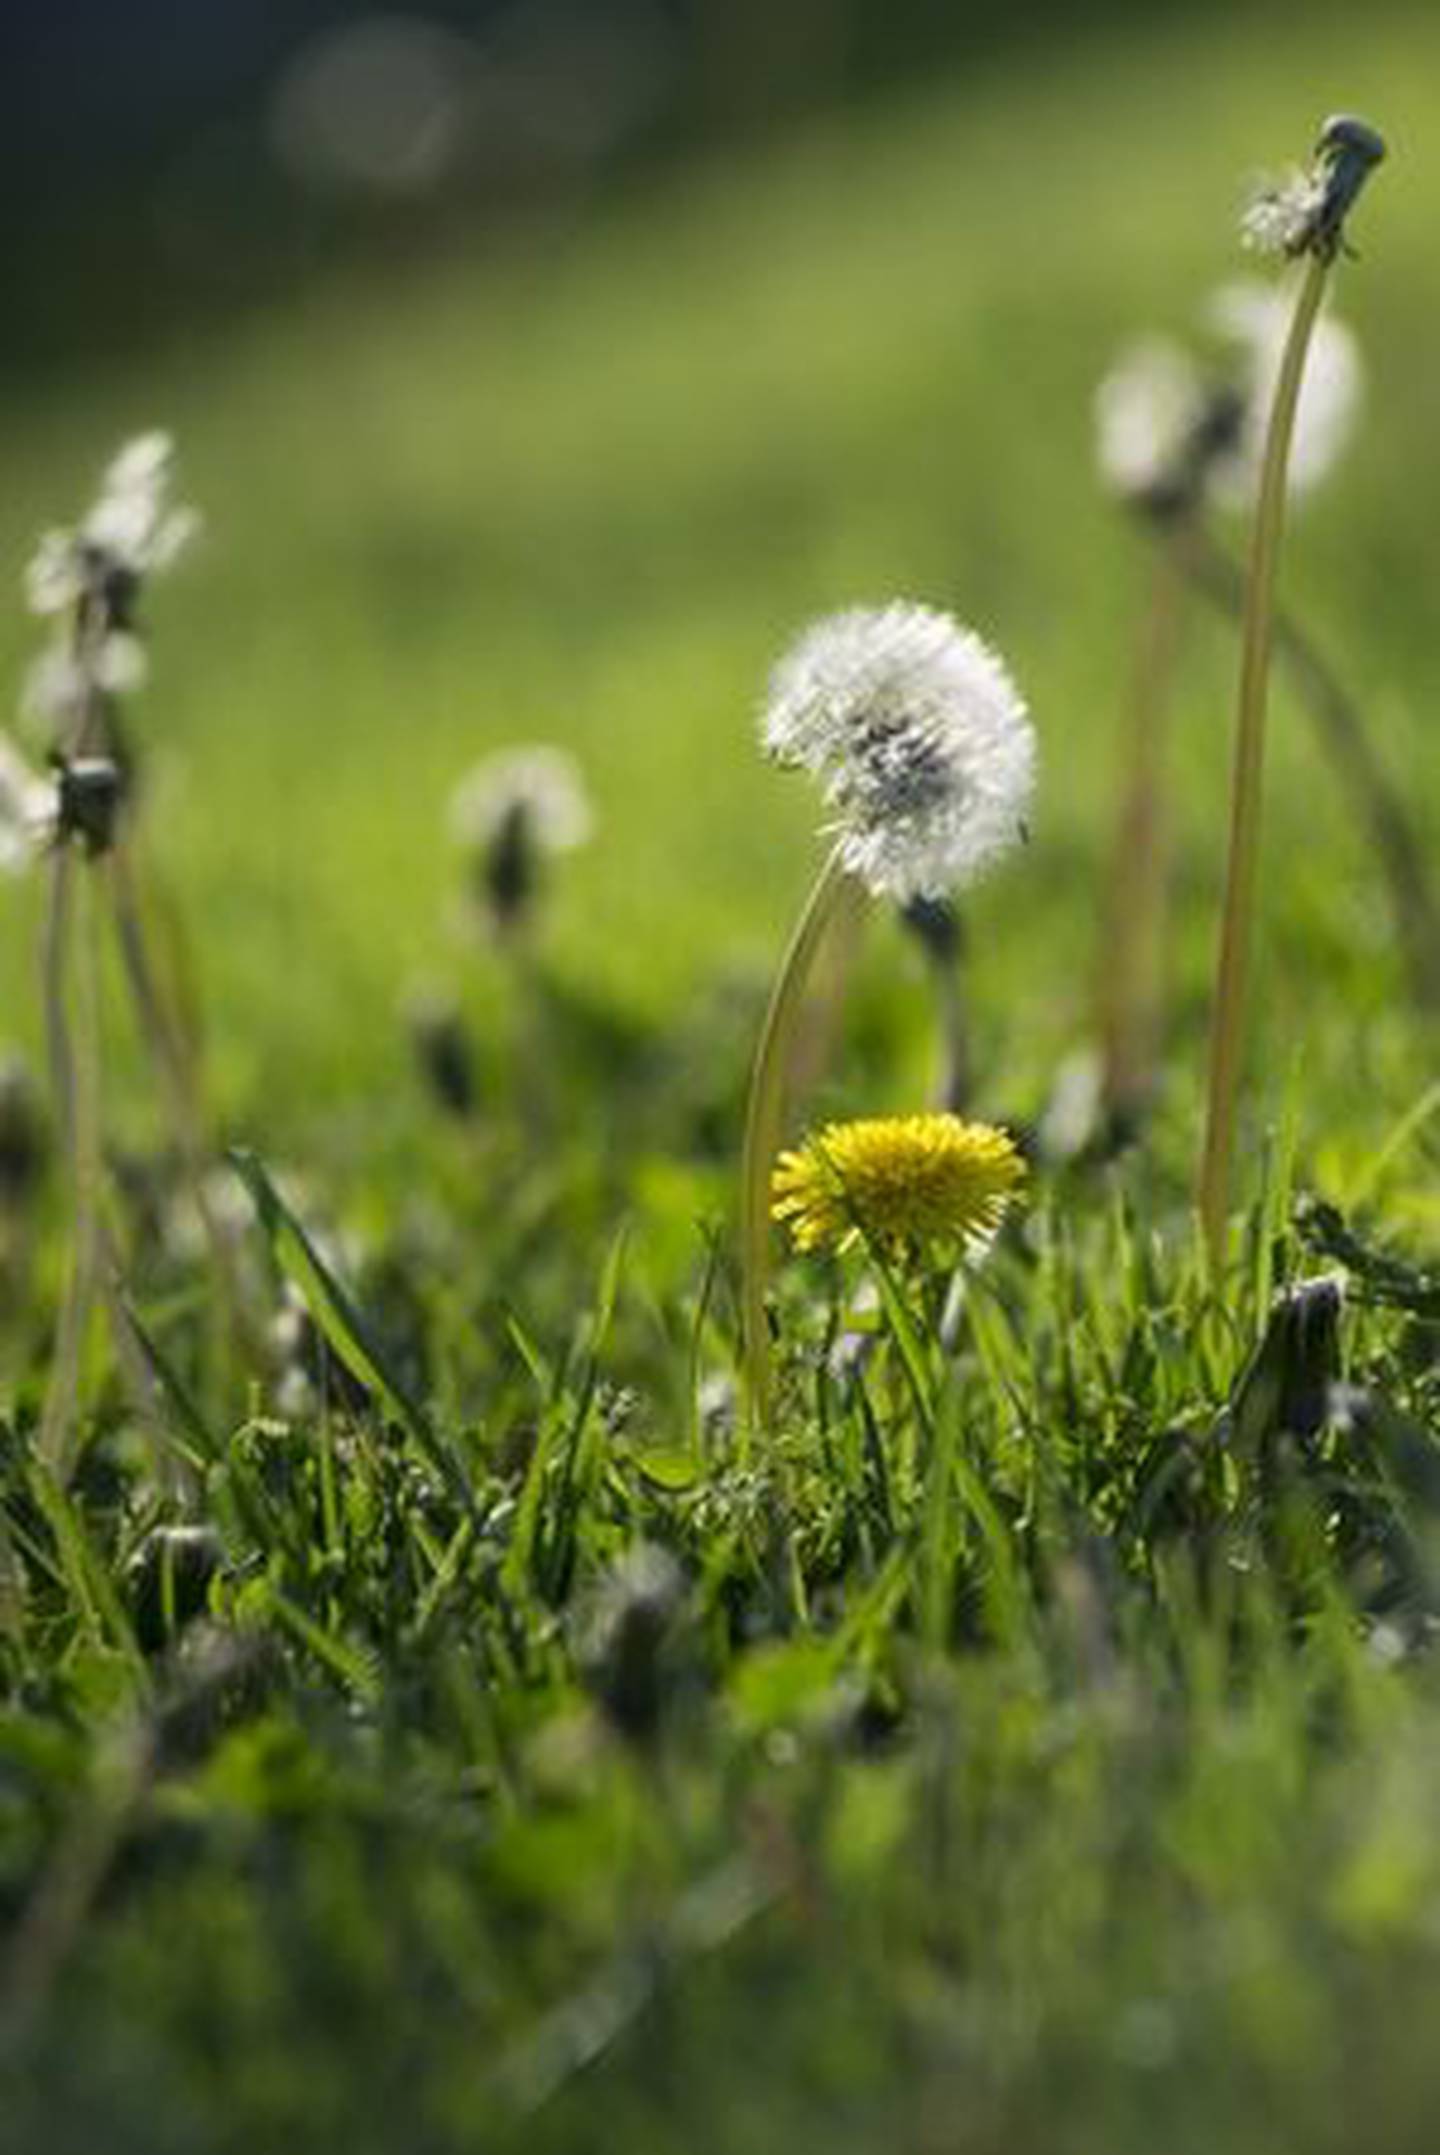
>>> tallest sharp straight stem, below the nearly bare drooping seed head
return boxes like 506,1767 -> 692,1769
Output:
1199,254 -> 1330,1267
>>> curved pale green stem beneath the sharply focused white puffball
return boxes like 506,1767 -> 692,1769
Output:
739,847 -> 860,1431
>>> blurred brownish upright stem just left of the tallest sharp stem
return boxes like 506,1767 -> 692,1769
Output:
1099,530 -> 1183,1131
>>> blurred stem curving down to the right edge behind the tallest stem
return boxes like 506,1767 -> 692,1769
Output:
1183,524 -> 1440,1011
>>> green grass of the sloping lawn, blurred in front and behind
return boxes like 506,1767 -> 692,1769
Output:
0,11 -> 1440,2155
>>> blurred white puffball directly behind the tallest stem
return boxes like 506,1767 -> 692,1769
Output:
1209,282 -> 1365,502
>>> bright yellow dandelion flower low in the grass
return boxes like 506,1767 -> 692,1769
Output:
772,1114 -> 1024,1256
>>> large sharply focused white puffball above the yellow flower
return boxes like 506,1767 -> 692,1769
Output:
761,601 -> 1035,903
